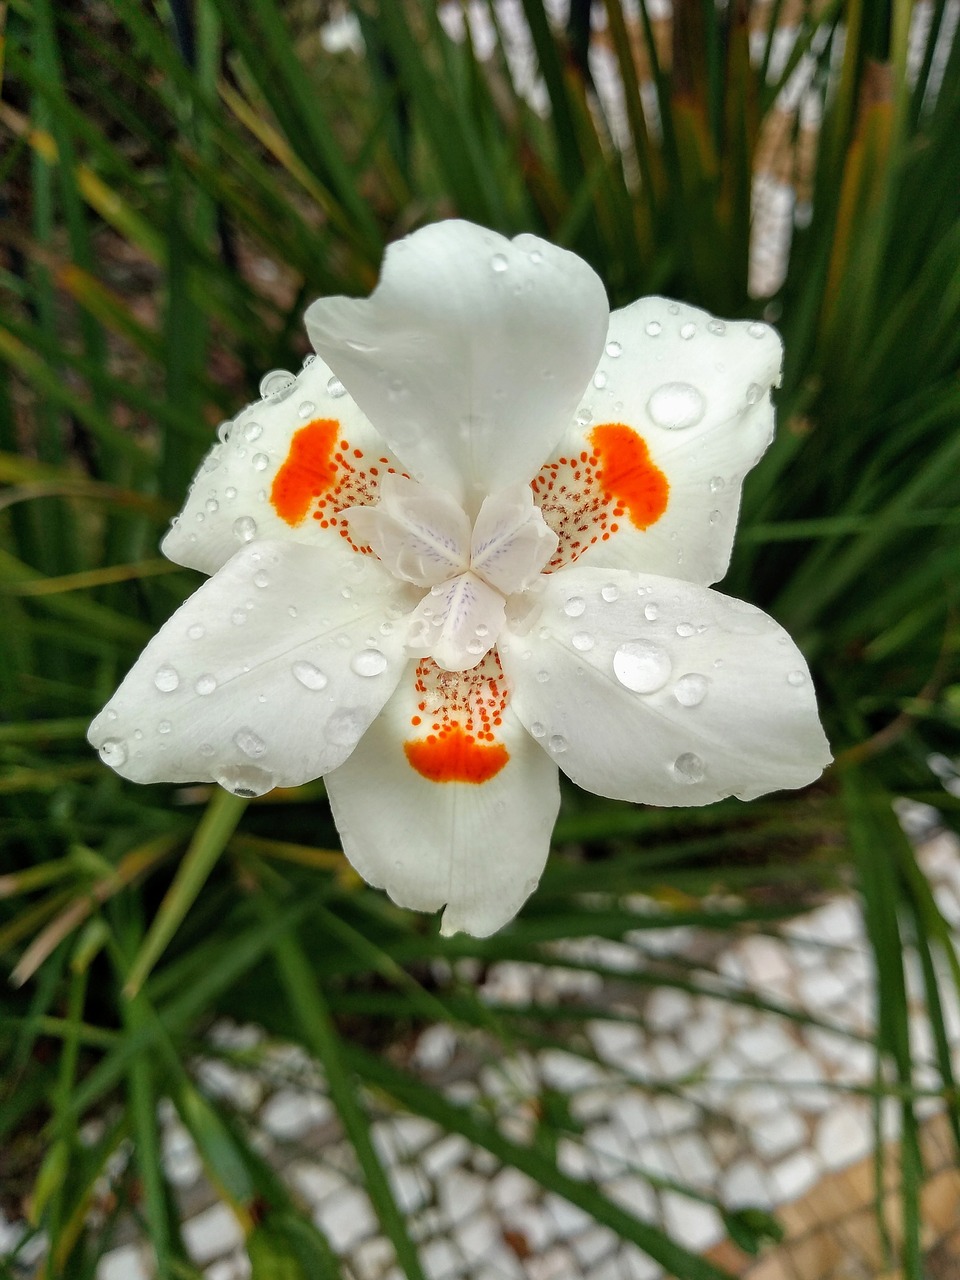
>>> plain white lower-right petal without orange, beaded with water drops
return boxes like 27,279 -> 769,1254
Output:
498,566 -> 829,805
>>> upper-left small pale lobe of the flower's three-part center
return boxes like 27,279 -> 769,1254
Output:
343,475 -> 470,586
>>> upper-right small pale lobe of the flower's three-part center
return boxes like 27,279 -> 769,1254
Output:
471,484 -> 557,595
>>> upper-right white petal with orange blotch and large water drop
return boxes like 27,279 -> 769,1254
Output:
534,298 -> 782,585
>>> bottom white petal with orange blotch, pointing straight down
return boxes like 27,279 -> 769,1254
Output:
326,657 -> 559,937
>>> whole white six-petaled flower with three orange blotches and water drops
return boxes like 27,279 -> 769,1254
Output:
90,221 -> 829,936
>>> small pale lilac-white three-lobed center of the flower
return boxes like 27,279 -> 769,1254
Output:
342,475 -> 558,671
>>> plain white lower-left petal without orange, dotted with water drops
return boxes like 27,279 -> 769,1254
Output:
90,543 -> 411,794
